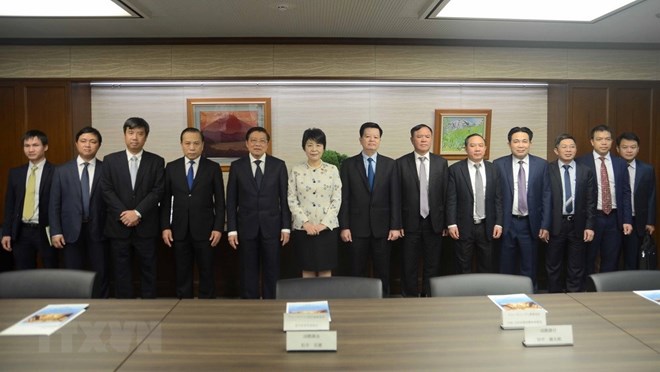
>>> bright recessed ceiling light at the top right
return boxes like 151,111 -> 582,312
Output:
428,0 -> 644,22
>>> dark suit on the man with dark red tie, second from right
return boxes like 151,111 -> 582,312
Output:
575,152 -> 632,275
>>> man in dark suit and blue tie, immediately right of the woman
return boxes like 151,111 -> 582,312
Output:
339,122 -> 401,296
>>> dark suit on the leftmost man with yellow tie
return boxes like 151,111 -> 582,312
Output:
2,161 -> 58,270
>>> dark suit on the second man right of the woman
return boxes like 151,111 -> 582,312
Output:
396,152 -> 448,297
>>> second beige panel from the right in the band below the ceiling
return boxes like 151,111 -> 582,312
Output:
474,48 -> 567,79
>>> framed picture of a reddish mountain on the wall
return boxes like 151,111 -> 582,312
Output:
186,98 -> 272,172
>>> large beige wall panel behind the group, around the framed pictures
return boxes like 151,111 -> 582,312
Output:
92,86 -> 547,166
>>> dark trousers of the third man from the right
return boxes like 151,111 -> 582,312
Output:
545,218 -> 587,293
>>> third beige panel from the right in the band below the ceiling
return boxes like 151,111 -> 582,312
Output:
376,46 -> 474,79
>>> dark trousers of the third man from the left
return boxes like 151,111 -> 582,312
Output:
110,236 -> 156,298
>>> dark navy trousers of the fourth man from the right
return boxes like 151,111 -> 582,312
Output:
500,217 -> 538,285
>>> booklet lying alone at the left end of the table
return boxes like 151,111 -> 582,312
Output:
0,304 -> 89,336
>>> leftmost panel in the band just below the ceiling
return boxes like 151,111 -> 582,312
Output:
0,46 -> 71,78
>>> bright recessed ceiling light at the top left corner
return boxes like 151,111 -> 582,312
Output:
0,0 -> 139,17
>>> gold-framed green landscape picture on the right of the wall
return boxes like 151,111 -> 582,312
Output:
433,109 -> 493,160
